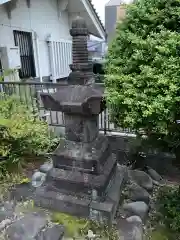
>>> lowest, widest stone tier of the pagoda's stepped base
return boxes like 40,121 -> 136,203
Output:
33,166 -> 126,223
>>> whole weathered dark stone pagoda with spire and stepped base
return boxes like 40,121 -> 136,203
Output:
35,17 -> 124,222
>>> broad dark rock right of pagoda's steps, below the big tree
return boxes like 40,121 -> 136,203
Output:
128,170 -> 153,191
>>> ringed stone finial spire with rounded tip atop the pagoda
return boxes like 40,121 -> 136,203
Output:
69,16 -> 94,85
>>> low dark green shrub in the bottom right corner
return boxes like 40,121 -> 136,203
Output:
158,187 -> 180,233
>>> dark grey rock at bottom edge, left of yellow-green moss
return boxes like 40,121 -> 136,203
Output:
36,225 -> 64,240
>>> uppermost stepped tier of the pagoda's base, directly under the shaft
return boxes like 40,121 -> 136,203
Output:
52,135 -> 111,174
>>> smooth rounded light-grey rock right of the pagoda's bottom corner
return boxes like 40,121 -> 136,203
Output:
123,202 -> 149,221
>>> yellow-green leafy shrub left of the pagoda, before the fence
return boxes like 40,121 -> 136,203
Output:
0,96 -> 58,176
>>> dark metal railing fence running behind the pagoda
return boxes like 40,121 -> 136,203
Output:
0,82 -> 133,134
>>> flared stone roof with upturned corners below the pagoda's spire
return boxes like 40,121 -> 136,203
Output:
41,86 -> 105,116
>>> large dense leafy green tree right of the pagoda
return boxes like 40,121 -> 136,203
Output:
105,0 -> 180,163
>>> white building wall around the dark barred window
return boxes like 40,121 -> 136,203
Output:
0,0 -> 71,77
